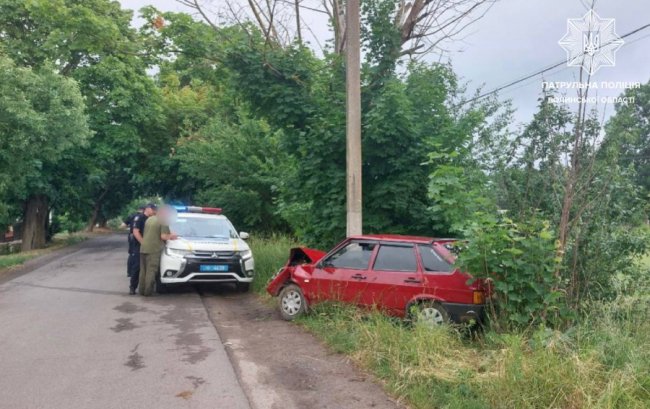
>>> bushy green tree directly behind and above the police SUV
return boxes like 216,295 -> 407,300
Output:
178,114 -> 288,232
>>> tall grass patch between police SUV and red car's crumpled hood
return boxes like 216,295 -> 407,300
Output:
249,235 -> 298,293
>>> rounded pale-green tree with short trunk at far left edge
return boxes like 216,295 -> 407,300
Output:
0,54 -> 91,250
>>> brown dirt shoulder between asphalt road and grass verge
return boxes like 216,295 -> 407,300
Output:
203,289 -> 403,409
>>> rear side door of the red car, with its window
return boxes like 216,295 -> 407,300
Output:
371,243 -> 422,314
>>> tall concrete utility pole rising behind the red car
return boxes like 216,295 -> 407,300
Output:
345,0 -> 362,237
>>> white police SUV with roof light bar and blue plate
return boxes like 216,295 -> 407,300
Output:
156,206 -> 255,292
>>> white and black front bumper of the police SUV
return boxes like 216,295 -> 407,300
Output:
160,253 -> 255,284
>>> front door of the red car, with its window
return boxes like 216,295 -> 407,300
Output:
310,240 -> 376,304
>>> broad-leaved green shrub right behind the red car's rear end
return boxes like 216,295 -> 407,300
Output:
450,213 -> 568,329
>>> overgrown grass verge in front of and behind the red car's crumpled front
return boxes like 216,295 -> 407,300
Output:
246,237 -> 650,409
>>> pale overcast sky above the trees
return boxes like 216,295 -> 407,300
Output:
120,0 -> 650,126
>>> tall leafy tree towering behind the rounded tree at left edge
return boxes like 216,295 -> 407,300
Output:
0,0 -> 164,242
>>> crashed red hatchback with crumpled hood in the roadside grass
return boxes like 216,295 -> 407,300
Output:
267,235 -> 489,324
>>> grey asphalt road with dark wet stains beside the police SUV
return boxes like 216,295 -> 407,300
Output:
0,235 -> 250,409
